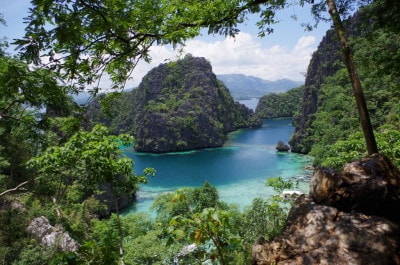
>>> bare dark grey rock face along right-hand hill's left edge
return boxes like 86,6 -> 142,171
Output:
289,30 -> 342,154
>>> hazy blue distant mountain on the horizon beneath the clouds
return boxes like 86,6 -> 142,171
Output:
217,74 -> 304,100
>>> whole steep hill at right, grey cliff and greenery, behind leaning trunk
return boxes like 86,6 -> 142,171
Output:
289,12 -> 400,167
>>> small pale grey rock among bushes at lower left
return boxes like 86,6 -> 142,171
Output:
27,216 -> 79,252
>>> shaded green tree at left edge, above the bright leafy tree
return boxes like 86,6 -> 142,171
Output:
0,53 -> 73,189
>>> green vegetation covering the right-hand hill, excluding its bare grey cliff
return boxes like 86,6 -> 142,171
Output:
297,13 -> 400,168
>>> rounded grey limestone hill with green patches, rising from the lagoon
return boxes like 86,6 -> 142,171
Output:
88,55 -> 261,152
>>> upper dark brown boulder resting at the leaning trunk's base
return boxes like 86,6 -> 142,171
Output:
310,154 -> 400,223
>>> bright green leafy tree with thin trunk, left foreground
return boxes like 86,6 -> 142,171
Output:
27,125 -> 155,262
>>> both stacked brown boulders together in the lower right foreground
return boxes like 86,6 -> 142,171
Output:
253,155 -> 400,265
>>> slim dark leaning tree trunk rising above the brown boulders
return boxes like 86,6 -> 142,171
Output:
326,0 -> 378,155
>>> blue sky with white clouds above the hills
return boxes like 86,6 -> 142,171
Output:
0,0 -> 330,87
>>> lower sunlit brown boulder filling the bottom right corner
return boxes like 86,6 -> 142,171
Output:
253,195 -> 400,265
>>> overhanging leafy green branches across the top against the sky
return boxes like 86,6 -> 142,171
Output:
15,0 -> 285,91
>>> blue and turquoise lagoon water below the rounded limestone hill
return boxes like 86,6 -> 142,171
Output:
125,119 -> 312,213
